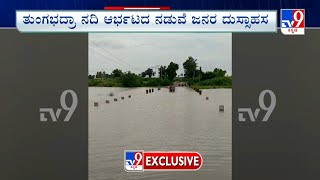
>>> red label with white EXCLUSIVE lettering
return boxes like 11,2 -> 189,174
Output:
143,151 -> 203,171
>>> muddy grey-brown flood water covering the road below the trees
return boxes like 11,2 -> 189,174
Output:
89,87 -> 232,180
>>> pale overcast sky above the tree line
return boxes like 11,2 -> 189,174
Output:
89,33 -> 232,75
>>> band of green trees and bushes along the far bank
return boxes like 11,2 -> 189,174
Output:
88,56 -> 232,89
